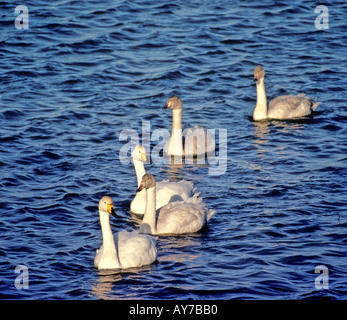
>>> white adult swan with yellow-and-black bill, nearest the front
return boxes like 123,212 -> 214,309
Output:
94,196 -> 157,269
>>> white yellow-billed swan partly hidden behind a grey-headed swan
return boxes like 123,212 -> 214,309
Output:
130,146 -> 195,215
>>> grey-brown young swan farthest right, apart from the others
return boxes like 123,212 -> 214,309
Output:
253,66 -> 319,121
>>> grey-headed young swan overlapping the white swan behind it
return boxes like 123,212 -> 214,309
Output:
138,173 -> 215,235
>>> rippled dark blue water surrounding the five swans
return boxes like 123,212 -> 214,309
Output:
0,0 -> 347,299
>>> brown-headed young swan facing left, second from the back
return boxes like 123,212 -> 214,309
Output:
164,96 -> 215,157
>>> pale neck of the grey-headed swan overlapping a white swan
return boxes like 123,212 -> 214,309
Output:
140,187 -> 157,234
